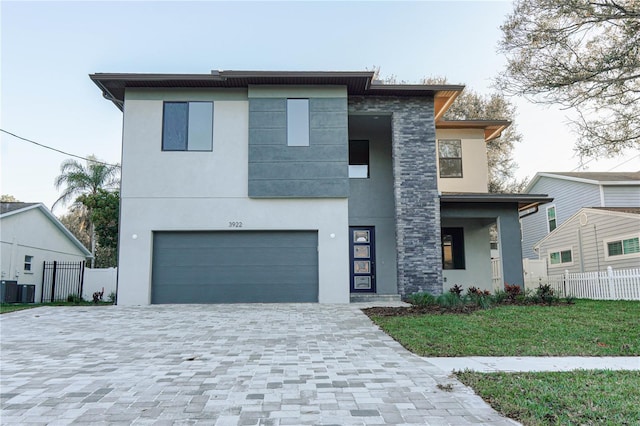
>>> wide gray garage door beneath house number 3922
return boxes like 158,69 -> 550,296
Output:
151,231 -> 318,303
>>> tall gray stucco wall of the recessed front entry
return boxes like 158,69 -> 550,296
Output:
349,116 -> 398,294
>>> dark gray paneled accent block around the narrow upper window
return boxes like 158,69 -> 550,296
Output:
248,98 -> 349,198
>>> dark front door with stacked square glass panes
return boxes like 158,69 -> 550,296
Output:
349,226 -> 376,293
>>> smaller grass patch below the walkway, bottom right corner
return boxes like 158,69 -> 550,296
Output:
456,370 -> 640,426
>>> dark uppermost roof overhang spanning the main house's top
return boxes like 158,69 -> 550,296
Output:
89,71 -> 464,112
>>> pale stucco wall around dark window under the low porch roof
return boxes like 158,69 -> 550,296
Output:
442,219 -> 493,292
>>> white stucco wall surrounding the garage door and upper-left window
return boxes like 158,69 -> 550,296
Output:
118,90 -> 349,305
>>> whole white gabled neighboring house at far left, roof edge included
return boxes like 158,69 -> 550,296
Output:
0,203 -> 91,302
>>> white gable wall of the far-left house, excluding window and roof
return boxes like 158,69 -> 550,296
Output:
0,208 -> 86,302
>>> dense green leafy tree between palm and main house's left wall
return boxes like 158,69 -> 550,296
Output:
78,188 -> 120,268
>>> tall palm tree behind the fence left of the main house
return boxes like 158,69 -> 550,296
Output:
51,155 -> 120,267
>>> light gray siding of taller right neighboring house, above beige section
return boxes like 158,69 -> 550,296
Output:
522,176 -> 602,259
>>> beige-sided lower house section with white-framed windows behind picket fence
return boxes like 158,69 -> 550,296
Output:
535,207 -> 640,275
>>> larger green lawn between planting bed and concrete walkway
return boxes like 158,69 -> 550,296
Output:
372,300 -> 640,356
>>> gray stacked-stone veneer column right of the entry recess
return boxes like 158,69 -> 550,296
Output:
349,97 -> 442,296
